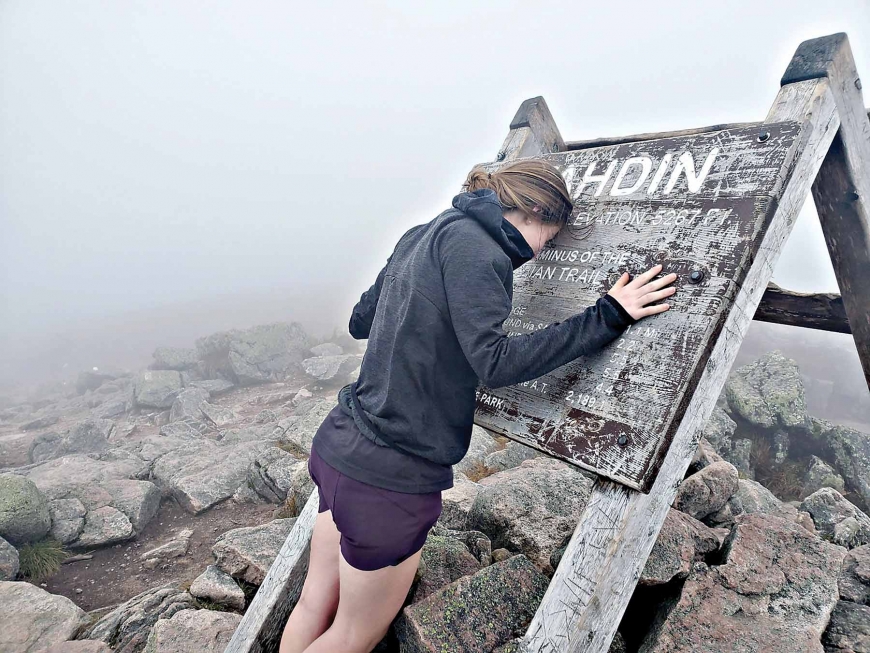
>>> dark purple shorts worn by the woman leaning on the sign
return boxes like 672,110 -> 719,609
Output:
308,448 -> 441,571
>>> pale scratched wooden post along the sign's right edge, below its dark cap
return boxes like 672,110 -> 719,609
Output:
521,52 -> 839,653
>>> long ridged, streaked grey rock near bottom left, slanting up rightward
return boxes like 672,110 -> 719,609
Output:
79,584 -> 197,651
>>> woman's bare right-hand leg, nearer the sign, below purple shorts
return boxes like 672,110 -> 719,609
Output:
305,548 -> 422,653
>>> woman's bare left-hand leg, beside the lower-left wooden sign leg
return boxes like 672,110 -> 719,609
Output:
278,510 -> 341,653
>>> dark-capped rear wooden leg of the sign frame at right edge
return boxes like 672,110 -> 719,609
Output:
782,33 -> 870,387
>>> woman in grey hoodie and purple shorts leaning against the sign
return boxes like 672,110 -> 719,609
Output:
280,160 -> 676,653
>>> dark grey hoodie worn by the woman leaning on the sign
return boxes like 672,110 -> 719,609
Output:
328,189 -> 635,487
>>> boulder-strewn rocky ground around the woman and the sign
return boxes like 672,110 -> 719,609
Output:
0,324 -> 870,653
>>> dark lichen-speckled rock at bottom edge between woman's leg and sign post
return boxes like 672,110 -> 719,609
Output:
395,555 -> 548,653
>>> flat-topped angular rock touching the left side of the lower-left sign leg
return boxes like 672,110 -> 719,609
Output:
212,517 -> 296,585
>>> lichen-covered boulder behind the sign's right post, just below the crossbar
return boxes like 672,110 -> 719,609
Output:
725,349 -> 807,429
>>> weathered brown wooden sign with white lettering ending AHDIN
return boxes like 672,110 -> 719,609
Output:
475,122 -> 800,492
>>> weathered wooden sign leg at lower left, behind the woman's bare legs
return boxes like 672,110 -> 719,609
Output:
225,487 -> 320,653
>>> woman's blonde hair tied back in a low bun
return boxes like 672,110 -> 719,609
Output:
462,159 -> 574,226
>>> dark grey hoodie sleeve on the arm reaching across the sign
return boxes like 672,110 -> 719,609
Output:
440,224 -> 636,388
